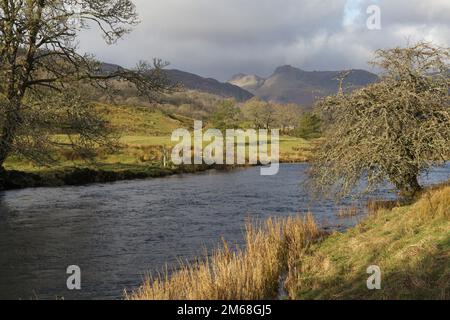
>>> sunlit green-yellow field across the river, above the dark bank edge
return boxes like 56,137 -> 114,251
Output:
5,104 -> 313,173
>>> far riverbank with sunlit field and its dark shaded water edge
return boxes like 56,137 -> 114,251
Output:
0,104 -> 314,190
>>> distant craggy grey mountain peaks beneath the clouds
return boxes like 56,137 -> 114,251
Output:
229,65 -> 378,106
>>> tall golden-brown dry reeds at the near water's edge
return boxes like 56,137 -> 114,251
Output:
125,214 -> 321,300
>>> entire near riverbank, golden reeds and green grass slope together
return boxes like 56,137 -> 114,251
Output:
126,182 -> 450,299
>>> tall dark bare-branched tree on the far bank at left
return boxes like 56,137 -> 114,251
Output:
0,0 -> 168,170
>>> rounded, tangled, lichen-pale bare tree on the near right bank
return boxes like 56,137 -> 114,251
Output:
310,42 -> 450,197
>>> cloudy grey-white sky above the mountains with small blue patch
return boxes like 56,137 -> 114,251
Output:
80,0 -> 450,80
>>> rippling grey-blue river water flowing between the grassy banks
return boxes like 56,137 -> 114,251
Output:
0,164 -> 450,299
